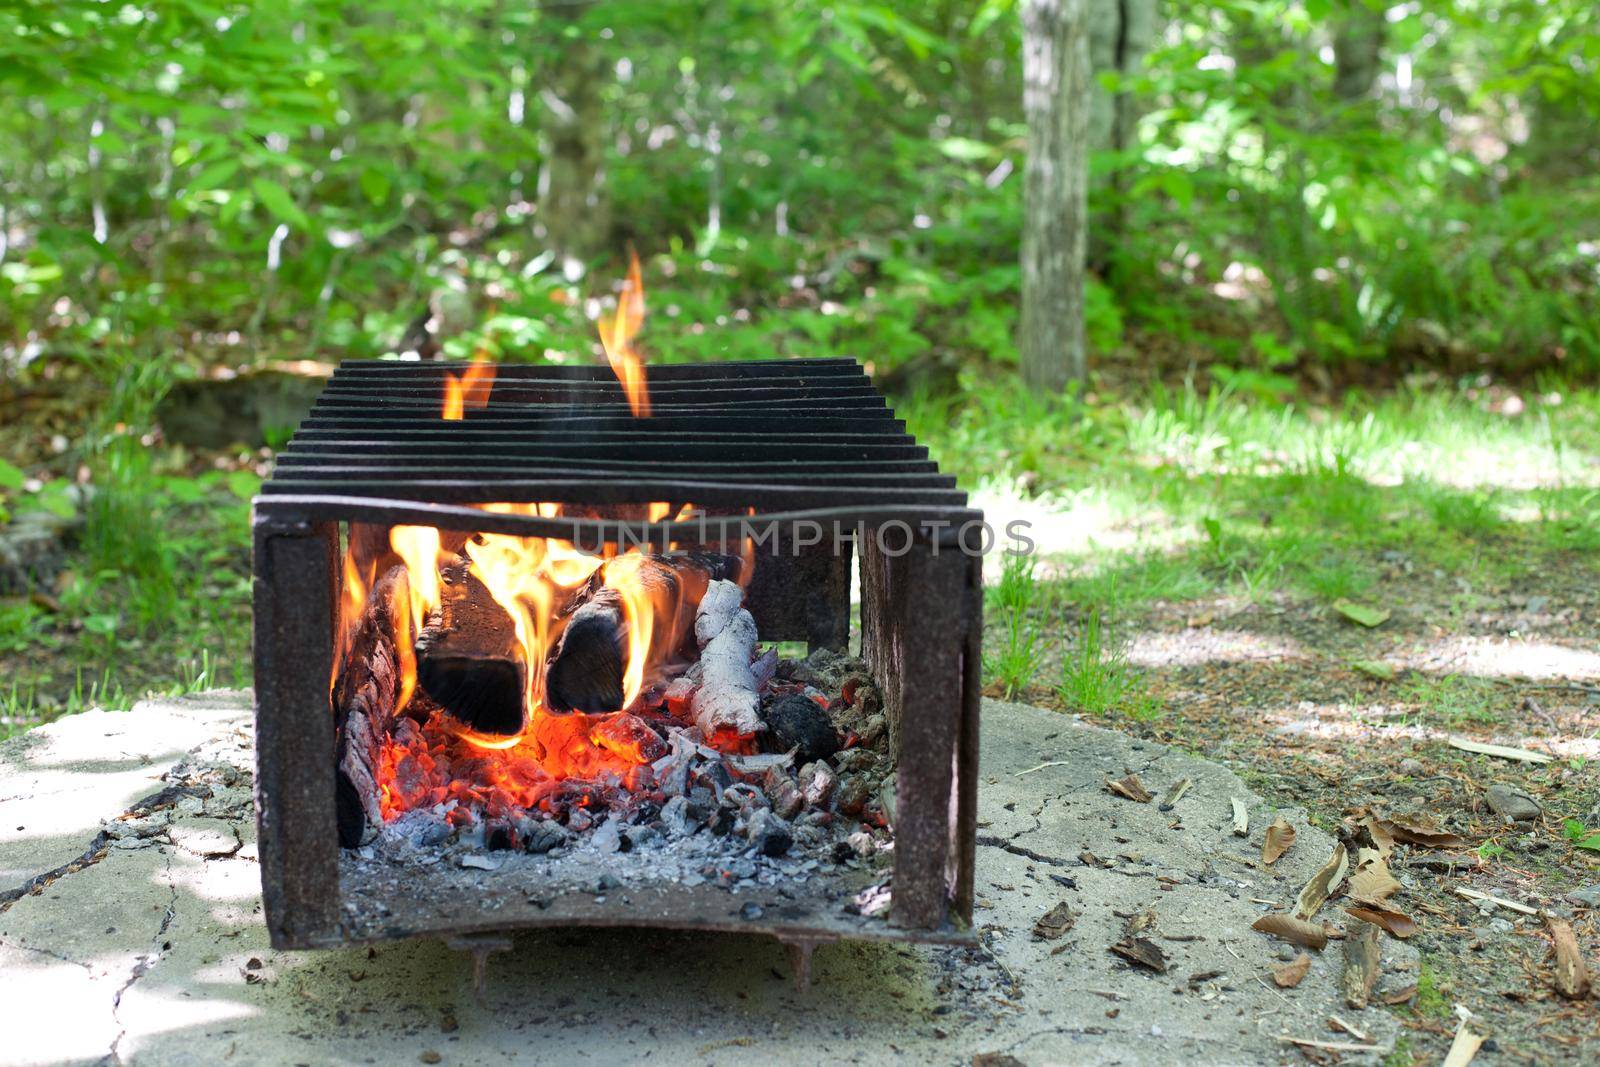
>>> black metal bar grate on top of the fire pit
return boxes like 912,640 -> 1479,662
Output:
262,360 -> 966,510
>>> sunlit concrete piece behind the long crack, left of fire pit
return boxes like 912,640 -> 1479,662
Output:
0,691 -> 250,891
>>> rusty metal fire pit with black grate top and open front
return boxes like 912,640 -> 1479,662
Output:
254,358 -> 982,969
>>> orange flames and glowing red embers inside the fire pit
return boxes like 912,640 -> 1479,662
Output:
341,502 -> 754,827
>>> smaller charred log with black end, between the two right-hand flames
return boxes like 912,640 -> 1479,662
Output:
544,553 -> 739,715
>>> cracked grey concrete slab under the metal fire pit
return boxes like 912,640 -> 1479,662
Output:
0,694 -> 1414,1067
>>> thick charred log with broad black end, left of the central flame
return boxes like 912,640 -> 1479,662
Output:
416,560 -> 528,734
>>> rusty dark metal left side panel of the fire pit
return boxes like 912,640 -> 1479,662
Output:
254,515 -> 339,949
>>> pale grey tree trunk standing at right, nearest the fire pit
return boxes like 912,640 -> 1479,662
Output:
1021,0 -> 1090,394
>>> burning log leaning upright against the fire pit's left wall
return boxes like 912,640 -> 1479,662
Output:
333,565 -> 411,848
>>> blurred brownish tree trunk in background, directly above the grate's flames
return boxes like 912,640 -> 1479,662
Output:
539,0 -> 611,262
